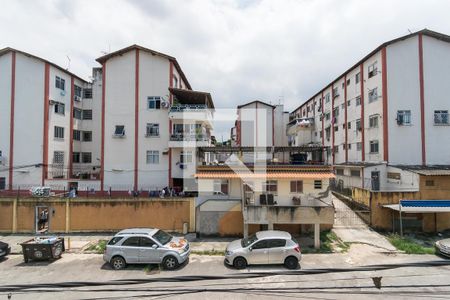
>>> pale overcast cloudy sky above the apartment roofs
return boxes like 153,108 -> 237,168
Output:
0,0 -> 450,139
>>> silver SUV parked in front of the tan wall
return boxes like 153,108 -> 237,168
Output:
103,228 -> 190,270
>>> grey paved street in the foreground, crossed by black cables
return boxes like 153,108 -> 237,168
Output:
0,245 -> 450,300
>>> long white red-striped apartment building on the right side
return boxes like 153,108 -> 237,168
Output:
287,29 -> 450,191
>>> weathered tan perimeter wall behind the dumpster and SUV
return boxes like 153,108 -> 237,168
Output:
0,198 -> 195,233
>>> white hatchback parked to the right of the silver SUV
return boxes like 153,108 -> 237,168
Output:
225,230 -> 302,269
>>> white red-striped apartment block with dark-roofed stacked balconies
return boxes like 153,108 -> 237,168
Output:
94,45 -> 214,192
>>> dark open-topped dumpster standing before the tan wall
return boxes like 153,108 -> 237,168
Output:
20,237 -> 65,263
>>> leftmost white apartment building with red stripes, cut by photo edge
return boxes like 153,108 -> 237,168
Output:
0,48 -> 99,191
